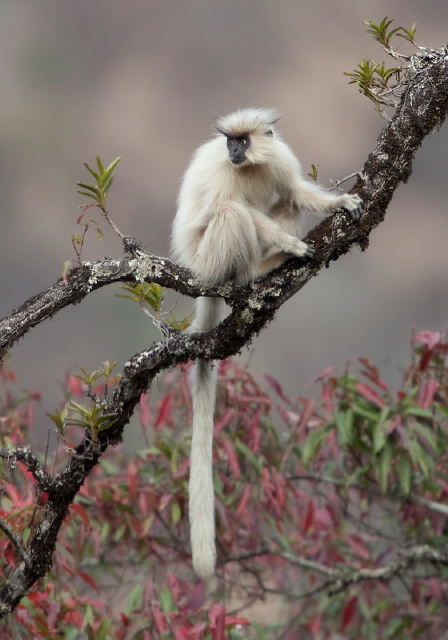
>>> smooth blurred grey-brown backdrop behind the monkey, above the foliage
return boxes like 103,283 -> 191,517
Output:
0,0 -> 448,436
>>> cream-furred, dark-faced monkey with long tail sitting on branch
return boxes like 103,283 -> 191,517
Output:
172,108 -> 363,578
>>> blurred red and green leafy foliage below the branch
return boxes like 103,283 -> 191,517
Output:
0,332 -> 448,640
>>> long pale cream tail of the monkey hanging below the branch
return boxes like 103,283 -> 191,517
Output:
189,298 -> 224,578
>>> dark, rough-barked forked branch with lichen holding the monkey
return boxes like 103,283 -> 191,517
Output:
0,47 -> 448,616
